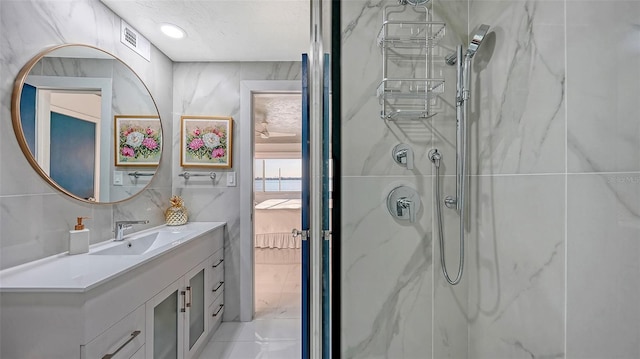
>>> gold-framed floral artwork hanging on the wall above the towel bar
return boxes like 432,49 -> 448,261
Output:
180,116 -> 233,168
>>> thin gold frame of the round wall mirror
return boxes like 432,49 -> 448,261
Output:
11,44 -> 165,204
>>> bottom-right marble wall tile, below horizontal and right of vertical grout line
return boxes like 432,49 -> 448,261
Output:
566,172 -> 640,359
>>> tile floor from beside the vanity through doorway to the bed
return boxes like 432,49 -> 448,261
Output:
200,248 -> 301,359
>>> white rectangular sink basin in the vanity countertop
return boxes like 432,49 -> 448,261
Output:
90,231 -> 193,256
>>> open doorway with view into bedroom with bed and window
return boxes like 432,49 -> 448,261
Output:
251,92 -> 302,325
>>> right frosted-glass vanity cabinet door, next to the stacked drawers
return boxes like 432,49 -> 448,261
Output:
184,261 -> 208,359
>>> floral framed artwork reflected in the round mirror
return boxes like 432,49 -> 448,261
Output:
114,115 -> 162,166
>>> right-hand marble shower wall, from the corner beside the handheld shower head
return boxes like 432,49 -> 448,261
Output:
468,0 -> 640,358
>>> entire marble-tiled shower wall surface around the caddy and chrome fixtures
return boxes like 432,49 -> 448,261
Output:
341,0 -> 640,358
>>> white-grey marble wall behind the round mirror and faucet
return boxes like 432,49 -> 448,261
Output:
0,0 -> 173,268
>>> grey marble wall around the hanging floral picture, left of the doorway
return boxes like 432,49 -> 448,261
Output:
171,62 -> 301,321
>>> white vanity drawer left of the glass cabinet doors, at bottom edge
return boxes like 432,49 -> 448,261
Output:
83,305 -> 146,359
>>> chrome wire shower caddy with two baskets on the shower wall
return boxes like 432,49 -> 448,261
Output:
376,3 -> 445,120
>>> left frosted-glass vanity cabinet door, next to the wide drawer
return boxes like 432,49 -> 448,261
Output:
146,279 -> 187,359
